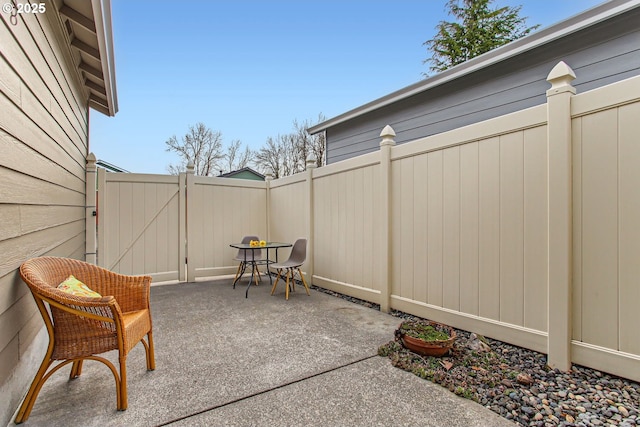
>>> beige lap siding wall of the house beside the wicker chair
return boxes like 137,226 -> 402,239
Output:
0,8 -> 88,404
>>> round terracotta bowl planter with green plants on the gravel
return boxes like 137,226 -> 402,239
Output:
396,320 -> 456,357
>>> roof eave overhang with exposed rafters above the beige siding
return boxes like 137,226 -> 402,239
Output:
54,0 -> 118,116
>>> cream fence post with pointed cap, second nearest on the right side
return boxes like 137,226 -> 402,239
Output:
380,125 -> 396,313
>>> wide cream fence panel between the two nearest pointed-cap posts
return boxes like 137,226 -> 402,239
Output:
390,106 -> 548,351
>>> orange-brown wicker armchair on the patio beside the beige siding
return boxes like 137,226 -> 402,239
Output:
15,257 -> 155,424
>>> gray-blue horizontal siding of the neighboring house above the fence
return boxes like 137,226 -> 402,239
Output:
318,2 -> 640,163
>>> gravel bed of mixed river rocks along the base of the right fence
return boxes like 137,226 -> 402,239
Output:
313,286 -> 640,427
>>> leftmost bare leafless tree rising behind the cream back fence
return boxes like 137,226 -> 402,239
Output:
165,122 -> 224,176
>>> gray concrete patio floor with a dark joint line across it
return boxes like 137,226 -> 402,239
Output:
7,278 -> 514,427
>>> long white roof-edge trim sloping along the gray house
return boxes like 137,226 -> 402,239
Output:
308,0 -> 640,135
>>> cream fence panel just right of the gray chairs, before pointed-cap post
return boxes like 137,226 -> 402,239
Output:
313,153 -> 386,303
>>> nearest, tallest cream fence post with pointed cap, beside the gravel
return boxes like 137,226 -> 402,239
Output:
547,62 -> 576,371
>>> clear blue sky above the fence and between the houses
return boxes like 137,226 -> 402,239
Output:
90,0 -> 602,174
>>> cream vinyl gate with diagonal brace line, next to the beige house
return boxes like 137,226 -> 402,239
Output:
95,168 -> 186,282
